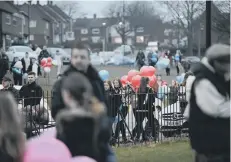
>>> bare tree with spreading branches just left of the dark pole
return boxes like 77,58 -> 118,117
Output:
161,1 -> 205,55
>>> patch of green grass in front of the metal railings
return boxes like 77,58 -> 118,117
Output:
115,141 -> 193,162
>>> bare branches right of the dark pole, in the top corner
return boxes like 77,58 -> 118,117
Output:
212,1 -> 230,37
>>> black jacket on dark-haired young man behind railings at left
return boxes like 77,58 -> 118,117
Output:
19,82 -> 43,107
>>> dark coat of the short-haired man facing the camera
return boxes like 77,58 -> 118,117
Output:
51,65 -> 114,162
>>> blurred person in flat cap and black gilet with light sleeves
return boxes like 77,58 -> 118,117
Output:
185,44 -> 230,162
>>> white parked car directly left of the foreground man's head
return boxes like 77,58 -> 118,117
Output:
47,47 -> 71,65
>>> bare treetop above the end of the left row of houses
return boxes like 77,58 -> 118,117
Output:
57,1 -> 79,19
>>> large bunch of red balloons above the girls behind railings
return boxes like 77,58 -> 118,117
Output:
120,66 -> 156,90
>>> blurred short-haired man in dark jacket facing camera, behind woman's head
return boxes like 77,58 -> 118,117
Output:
51,43 -> 115,162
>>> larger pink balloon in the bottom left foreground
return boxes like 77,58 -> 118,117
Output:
23,138 -> 71,162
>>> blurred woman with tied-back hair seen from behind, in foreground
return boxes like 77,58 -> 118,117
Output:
55,73 -> 115,162
